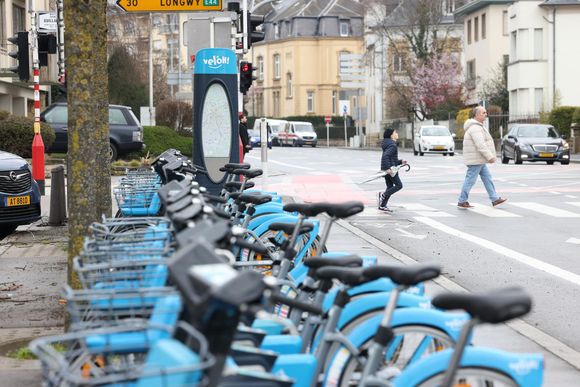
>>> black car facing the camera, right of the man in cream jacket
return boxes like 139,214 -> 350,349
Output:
501,124 -> 570,165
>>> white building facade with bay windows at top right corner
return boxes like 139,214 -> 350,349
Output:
508,0 -> 580,117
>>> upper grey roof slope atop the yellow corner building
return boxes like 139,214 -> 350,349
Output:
266,0 -> 364,22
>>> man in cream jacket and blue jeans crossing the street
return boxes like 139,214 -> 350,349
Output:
457,106 -> 507,208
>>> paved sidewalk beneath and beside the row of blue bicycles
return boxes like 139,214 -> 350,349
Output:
0,180 -> 580,387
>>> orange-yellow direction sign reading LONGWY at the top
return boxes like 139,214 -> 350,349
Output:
117,0 -> 222,12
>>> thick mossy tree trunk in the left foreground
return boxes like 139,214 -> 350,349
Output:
64,0 -> 111,286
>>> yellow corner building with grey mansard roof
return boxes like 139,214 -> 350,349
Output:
246,0 -> 363,118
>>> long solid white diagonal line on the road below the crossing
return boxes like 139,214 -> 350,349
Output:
414,217 -> 580,286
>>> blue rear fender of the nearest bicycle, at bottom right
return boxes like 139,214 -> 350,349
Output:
393,347 -> 544,387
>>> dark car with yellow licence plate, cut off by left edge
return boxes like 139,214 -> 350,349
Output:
0,151 -> 40,236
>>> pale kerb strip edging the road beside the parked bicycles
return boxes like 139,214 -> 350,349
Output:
336,219 -> 580,369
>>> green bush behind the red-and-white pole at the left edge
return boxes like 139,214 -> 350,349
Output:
0,114 -> 55,158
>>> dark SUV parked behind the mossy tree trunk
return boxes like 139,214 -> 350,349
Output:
40,102 -> 145,160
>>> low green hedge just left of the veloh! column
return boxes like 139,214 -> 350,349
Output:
140,126 -> 193,157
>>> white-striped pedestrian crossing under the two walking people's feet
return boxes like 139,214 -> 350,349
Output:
357,200 -> 580,219
